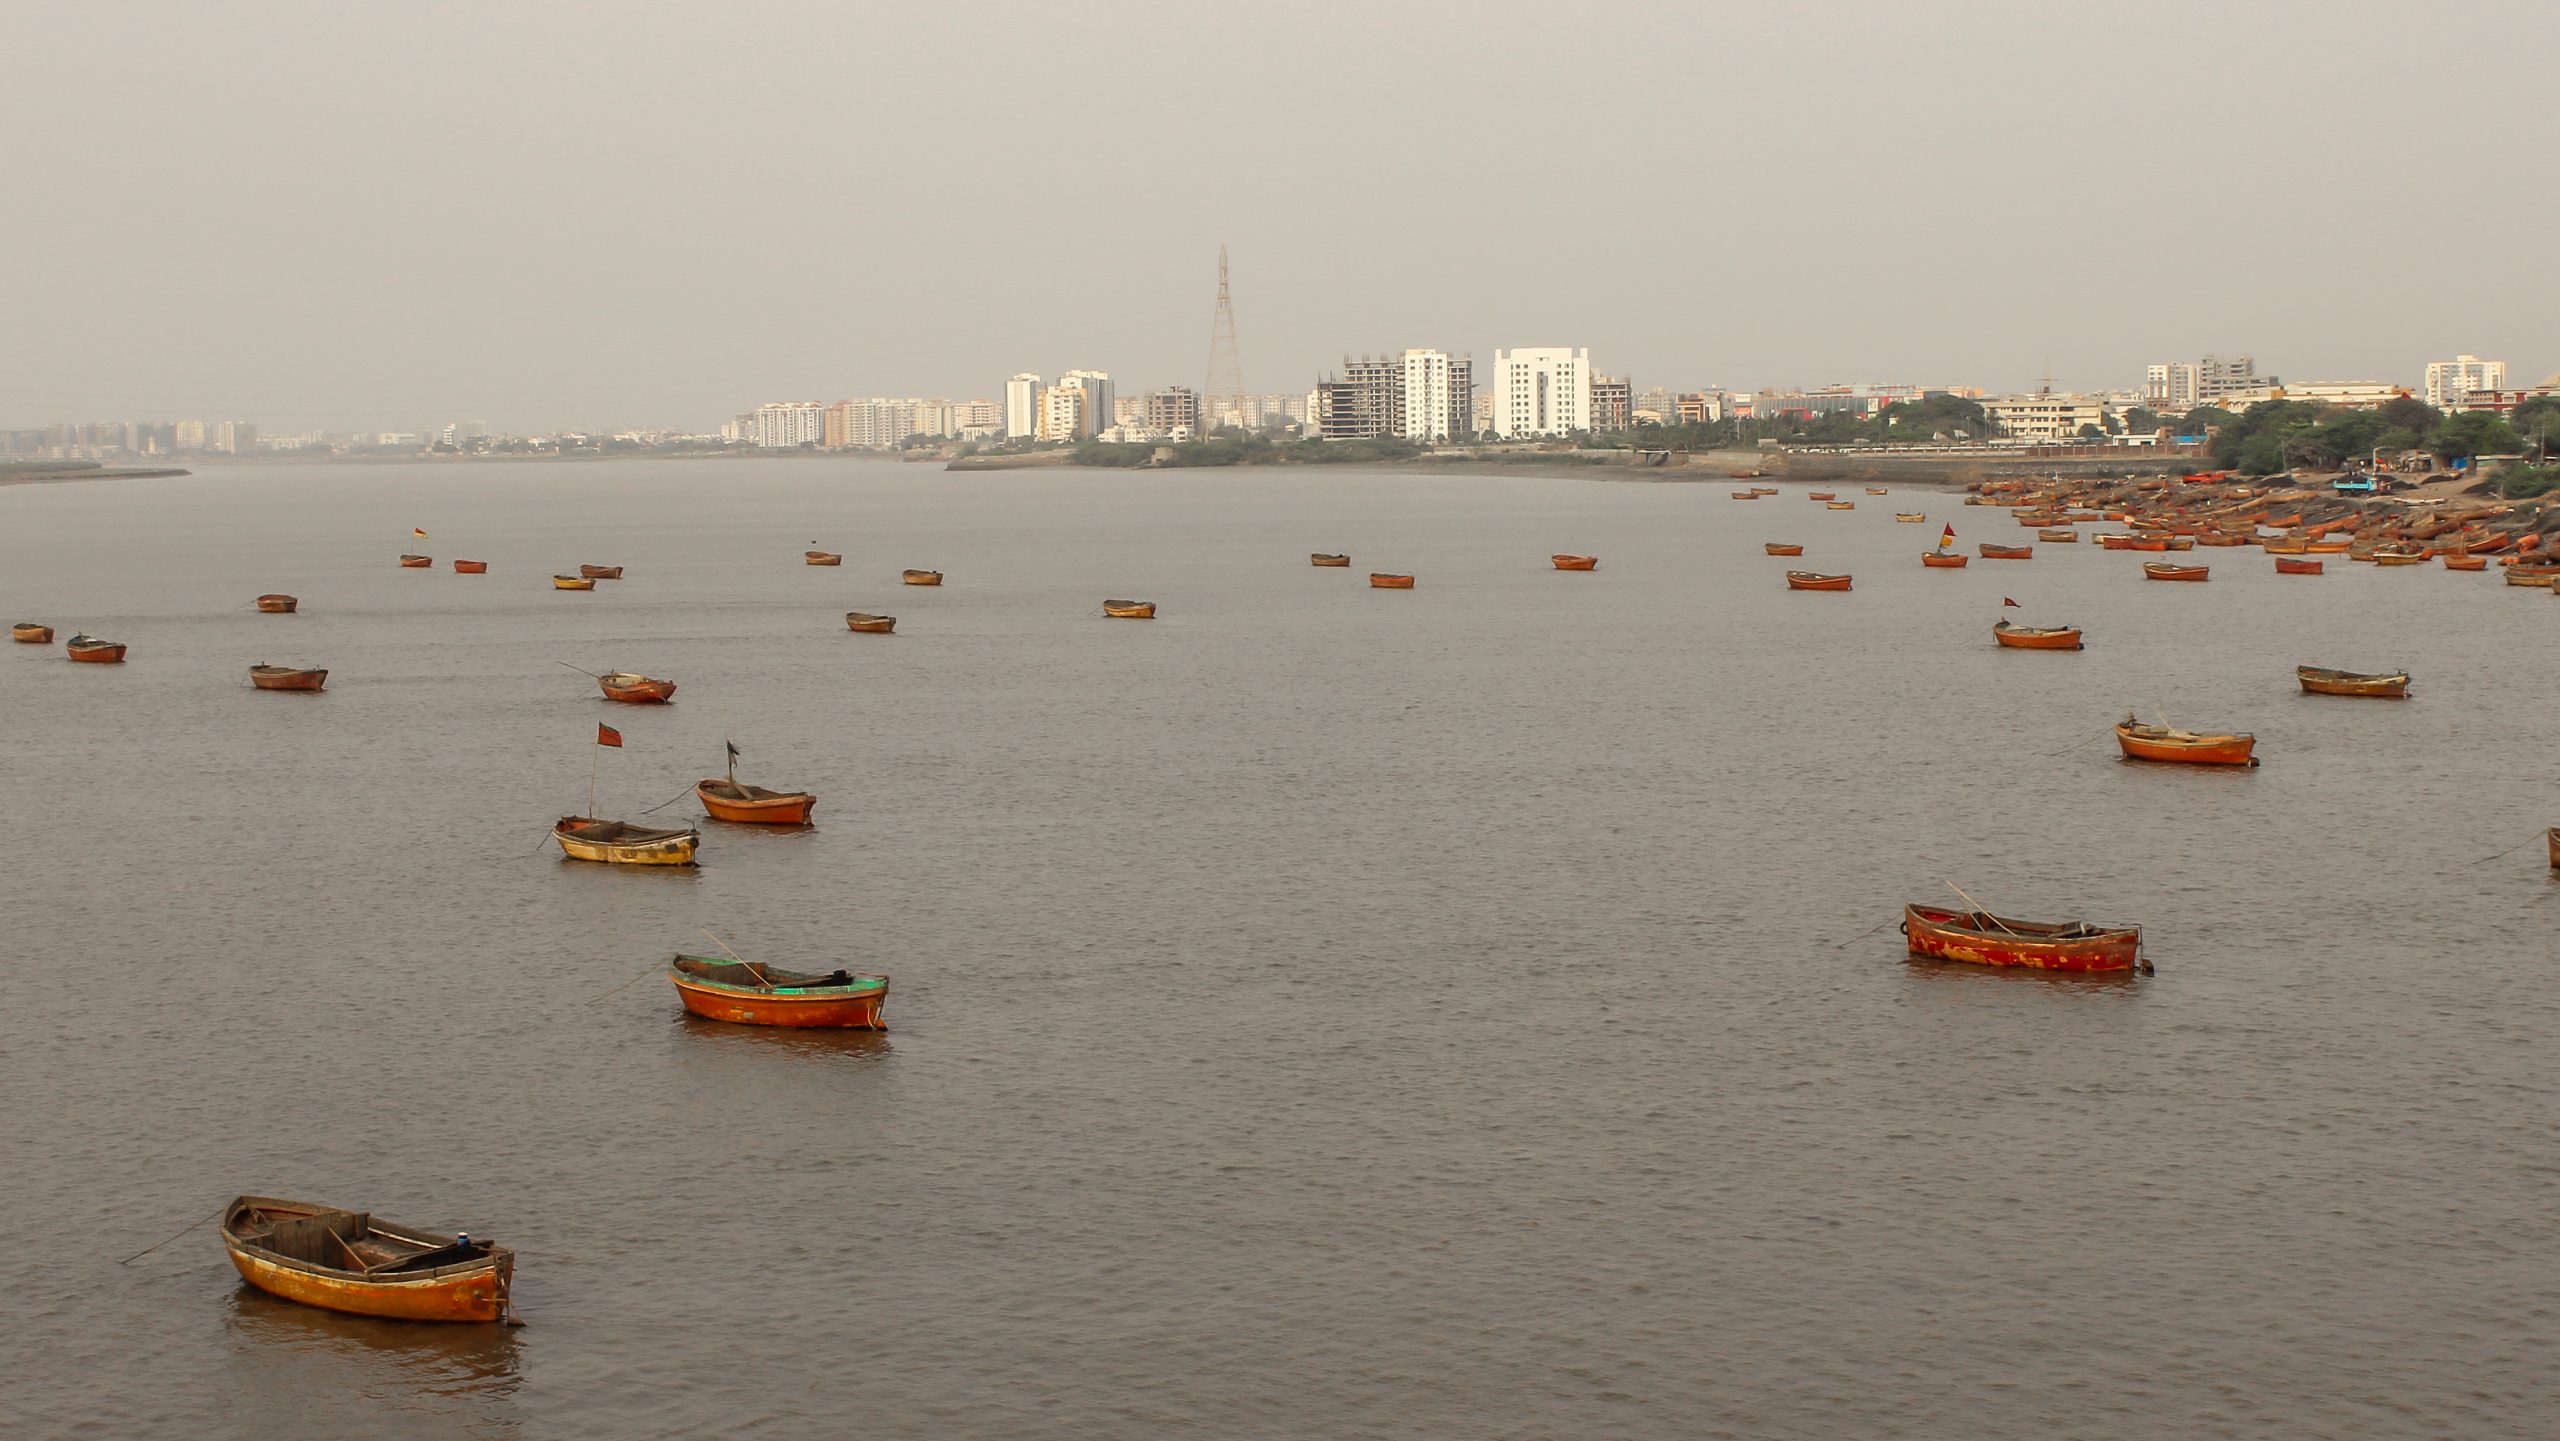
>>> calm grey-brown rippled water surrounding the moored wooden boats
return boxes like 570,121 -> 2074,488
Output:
0,461 -> 2560,1438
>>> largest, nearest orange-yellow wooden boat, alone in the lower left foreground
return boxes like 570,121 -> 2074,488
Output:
223,1195 -> 515,1321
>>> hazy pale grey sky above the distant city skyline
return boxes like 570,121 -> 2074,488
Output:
0,0 -> 2560,430
